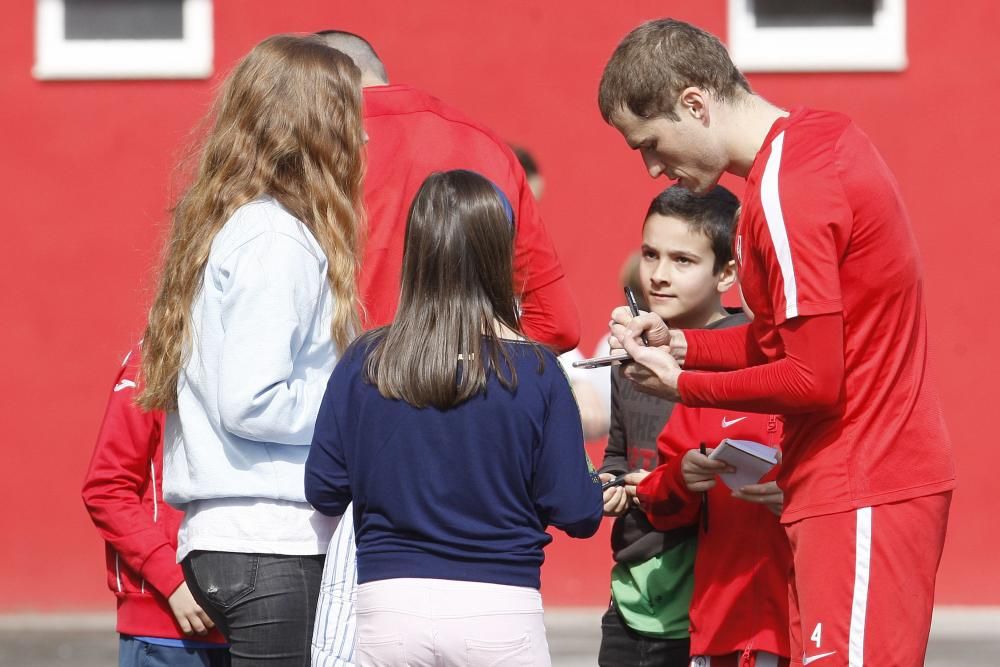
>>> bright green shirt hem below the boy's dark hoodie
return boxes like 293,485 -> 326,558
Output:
611,538 -> 698,639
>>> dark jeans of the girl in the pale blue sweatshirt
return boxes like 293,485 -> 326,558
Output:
181,551 -> 325,667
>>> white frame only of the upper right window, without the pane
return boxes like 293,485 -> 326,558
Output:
728,0 -> 907,72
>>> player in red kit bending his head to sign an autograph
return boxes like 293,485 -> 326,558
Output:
598,19 -> 955,667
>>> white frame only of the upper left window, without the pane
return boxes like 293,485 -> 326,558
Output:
33,0 -> 213,79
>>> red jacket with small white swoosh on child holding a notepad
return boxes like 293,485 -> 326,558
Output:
637,404 -> 792,657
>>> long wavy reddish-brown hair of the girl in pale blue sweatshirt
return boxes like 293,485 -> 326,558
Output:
139,35 -> 364,410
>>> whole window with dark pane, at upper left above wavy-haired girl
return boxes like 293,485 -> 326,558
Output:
34,0 -> 212,79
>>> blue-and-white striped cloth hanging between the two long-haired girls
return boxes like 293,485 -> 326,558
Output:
312,505 -> 358,667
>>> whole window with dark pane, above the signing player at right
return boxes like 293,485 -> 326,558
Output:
729,0 -> 906,72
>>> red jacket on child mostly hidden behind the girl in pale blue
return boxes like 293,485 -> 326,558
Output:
83,346 -> 225,644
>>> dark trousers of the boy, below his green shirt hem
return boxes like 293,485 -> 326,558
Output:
597,603 -> 691,667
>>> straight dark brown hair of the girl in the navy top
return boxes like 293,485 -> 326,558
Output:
360,170 -> 542,409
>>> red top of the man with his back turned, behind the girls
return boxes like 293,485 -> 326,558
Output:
359,85 -> 580,351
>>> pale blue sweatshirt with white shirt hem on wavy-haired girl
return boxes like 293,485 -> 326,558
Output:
163,197 -> 337,560
